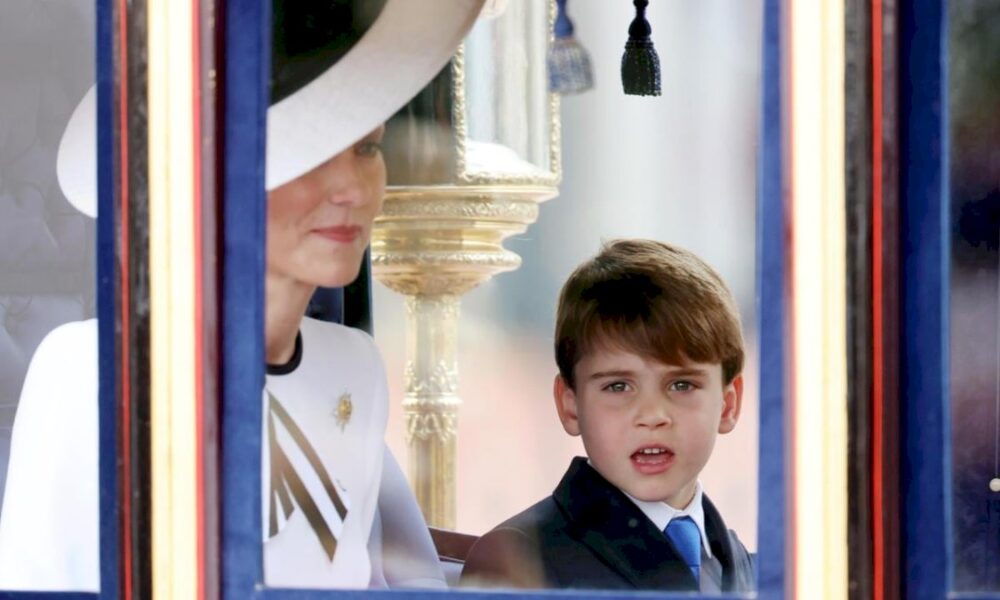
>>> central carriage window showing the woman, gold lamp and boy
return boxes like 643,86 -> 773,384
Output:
232,1 -> 784,597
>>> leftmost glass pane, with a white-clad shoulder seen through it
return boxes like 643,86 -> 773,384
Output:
0,0 -> 98,590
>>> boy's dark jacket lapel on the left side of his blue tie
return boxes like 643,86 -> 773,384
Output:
552,457 -> 700,591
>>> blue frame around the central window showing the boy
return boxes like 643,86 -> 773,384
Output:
221,0 -> 789,600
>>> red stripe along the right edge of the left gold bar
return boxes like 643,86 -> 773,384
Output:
191,0 -> 205,600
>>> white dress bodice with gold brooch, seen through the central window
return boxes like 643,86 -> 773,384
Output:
261,318 -> 389,588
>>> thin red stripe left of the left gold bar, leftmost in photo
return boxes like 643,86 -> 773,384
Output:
118,0 -> 133,600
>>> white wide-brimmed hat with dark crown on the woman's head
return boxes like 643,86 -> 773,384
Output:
56,0 -> 484,215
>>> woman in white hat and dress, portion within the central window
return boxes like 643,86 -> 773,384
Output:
262,0 -> 482,587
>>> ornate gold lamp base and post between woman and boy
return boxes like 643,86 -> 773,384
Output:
372,185 -> 557,529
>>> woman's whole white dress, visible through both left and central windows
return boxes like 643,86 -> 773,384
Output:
0,319 -> 444,592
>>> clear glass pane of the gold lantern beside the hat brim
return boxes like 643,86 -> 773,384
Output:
385,2 -> 553,186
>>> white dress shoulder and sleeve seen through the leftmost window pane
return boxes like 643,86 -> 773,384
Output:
0,319 -> 100,591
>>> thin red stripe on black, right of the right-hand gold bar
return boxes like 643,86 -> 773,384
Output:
871,0 -> 885,600
